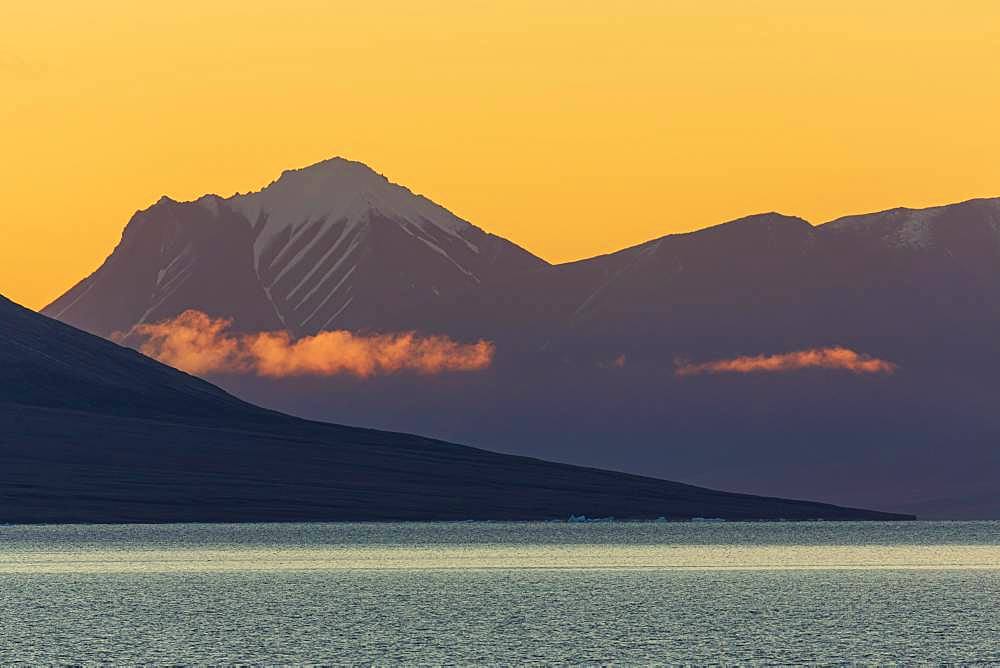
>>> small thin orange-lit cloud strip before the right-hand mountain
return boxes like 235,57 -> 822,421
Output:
676,346 -> 896,376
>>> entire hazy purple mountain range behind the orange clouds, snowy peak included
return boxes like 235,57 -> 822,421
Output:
44,159 -> 1000,517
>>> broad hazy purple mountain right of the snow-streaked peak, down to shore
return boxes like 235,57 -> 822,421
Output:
213,199 -> 1000,518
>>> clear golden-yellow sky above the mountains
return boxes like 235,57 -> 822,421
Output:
0,0 -> 1000,308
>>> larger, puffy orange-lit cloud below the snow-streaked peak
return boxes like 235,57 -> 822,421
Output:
134,310 -> 494,378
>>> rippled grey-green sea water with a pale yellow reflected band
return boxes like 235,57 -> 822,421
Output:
0,522 -> 1000,665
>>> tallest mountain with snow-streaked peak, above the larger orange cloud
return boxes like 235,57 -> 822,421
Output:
43,158 -> 546,336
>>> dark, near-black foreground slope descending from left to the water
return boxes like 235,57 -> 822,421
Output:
0,297 -> 907,522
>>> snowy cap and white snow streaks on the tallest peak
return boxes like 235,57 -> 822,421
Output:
219,158 -> 500,327
